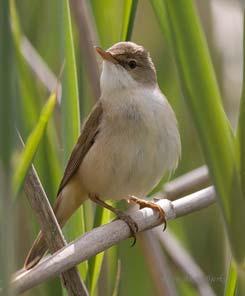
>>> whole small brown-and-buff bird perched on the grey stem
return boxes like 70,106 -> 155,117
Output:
25,42 -> 181,269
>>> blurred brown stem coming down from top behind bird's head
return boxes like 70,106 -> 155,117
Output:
70,0 -> 100,103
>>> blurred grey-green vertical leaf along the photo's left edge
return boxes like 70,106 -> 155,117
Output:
0,0 -> 15,296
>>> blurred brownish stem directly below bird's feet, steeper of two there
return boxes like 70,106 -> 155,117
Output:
138,229 -> 178,296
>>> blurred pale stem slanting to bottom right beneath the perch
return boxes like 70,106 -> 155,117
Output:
153,227 -> 215,296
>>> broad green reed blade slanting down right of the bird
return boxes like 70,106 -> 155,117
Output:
158,0 -> 245,262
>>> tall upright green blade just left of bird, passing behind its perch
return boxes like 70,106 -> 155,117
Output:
61,0 -> 87,277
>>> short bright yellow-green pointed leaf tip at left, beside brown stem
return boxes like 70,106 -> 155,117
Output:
13,93 -> 56,195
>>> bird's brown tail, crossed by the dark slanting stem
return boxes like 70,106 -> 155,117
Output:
24,185 -> 86,269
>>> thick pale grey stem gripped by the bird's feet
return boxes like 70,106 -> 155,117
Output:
13,187 -> 216,292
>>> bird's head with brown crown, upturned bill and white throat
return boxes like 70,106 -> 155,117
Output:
96,42 -> 157,89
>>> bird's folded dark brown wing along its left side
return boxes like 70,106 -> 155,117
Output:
57,102 -> 103,196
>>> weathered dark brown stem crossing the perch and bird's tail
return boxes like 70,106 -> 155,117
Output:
24,166 -> 88,296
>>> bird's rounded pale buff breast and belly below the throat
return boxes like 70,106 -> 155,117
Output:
79,86 -> 179,199
